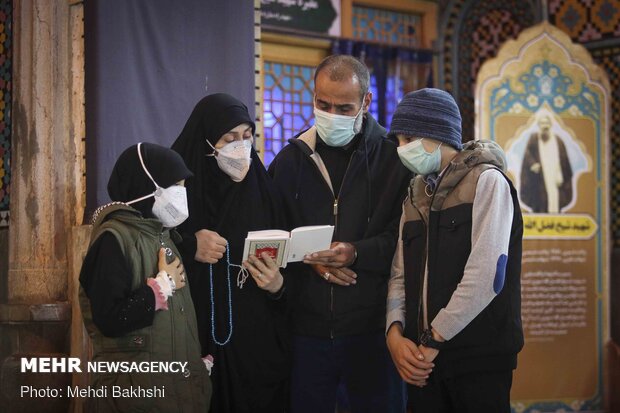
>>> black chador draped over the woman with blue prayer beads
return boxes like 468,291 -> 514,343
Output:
172,94 -> 289,412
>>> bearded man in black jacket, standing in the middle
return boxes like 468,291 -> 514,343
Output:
269,56 -> 410,413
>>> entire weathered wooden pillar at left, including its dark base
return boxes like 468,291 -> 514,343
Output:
0,0 -> 85,412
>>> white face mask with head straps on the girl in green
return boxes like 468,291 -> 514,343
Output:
127,143 -> 189,228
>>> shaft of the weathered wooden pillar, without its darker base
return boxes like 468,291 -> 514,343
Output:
8,0 -> 83,303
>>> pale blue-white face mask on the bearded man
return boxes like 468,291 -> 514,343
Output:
314,105 -> 364,146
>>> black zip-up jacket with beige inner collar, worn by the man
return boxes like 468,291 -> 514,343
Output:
269,114 -> 411,338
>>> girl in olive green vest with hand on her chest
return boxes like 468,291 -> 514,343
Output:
80,143 -> 211,412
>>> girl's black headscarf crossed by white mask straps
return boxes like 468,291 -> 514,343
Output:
108,143 -> 192,217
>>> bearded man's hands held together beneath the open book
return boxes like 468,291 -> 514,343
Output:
304,242 -> 357,287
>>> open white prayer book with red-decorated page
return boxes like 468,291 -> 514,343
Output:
243,225 -> 334,267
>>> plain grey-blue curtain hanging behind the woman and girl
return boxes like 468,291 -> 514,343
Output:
84,0 -> 255,212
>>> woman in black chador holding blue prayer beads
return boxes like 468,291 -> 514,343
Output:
172,94 -> 289,413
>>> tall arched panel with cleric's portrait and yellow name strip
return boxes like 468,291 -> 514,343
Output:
475,23 -> 610,413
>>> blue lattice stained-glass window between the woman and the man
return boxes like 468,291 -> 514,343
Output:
263,61 -> 314,166
